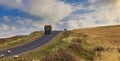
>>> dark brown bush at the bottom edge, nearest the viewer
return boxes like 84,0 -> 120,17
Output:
41,48 -> 76,61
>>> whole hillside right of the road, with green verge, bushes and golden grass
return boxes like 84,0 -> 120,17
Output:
2,25 -> 120,61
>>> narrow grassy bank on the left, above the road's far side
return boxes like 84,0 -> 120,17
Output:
0,31 -> 43,50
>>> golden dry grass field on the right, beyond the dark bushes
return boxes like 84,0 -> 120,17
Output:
74,25 -> 120,61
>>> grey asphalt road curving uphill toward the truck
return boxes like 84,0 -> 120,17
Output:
0,31 -> 60,57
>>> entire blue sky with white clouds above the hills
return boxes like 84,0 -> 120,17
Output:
0,0 -> 120,38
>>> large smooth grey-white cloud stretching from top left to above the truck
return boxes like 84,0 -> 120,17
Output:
0,0 -> 72,21
